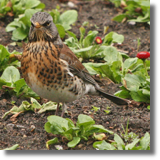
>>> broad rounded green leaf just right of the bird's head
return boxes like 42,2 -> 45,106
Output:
59,10 -> 78,31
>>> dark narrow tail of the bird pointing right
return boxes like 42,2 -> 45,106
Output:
96,88 -> 129,105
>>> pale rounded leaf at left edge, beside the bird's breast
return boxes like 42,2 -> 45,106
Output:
1,66 -> 20,84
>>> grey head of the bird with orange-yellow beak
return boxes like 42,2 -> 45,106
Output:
29,12 -> 59,42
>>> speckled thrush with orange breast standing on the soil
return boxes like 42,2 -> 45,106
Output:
21,12 -> 129,117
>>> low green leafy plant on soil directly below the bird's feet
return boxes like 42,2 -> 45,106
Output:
44,114 -> 113,148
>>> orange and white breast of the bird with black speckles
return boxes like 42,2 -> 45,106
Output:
21,41 -> 85,103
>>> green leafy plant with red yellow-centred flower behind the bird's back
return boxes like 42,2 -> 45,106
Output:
65,26 -> 124,59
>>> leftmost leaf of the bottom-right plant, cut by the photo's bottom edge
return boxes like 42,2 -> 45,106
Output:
93,140 -> 116,150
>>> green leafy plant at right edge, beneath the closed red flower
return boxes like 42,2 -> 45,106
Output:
115,52 -> 150,103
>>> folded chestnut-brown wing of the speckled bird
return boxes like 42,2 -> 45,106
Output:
59,44 -> 97,85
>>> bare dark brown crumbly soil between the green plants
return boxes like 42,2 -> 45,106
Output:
0,0 -> 150,150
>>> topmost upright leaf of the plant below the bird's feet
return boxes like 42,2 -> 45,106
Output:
77,114 -> 95,126
